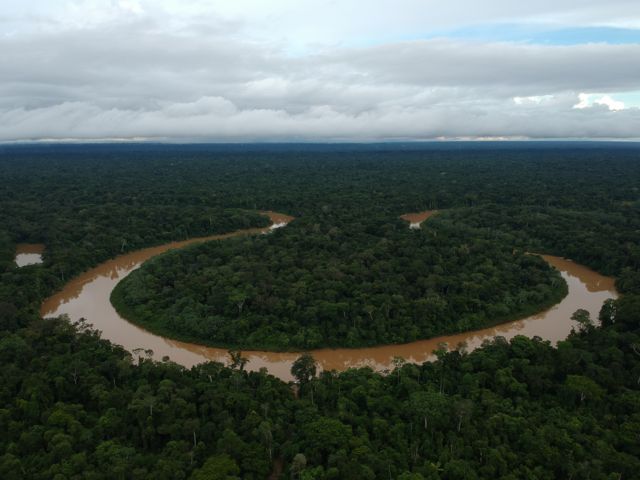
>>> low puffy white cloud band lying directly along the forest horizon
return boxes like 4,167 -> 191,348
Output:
5,90 -> 640,141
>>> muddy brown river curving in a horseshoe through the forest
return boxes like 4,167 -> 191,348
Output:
40,212 -> 617,381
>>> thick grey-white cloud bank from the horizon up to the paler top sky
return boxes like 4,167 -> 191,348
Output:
0,1 -> 640,141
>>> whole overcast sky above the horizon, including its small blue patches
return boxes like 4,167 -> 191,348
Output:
0,0 -> 640,142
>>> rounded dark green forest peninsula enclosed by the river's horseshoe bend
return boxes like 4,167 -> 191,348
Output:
112,213 -> 566,349
